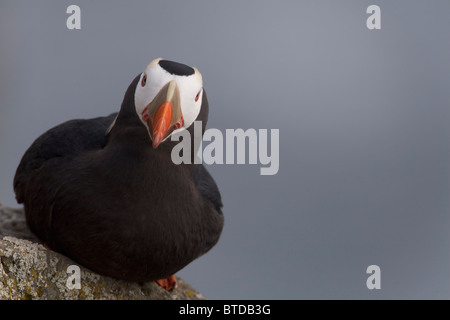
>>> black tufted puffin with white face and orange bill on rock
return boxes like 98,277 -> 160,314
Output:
14,58 -> 224,290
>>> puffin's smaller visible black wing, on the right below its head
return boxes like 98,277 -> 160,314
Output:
194,164 -> 223,213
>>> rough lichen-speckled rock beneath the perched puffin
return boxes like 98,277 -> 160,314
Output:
0,204 -> 205,300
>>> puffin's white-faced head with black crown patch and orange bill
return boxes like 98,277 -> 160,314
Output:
134,58 -> 206,149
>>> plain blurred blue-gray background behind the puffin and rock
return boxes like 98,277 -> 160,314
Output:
0,0 -> 450,299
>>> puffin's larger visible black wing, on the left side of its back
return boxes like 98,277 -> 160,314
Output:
14,113 -> 117,203
